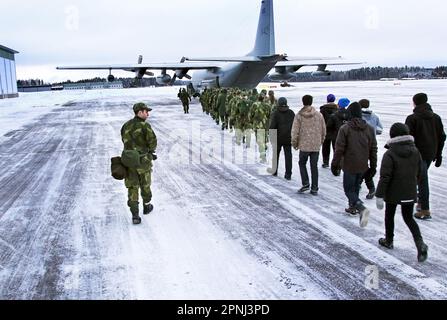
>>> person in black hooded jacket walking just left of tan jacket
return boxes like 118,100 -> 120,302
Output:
270,98 -> 295,180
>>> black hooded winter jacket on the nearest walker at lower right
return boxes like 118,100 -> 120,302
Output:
376,136 -> 422,204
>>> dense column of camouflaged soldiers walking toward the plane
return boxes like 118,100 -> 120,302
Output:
200,88 -> 277,163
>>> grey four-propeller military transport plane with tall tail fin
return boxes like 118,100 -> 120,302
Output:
57,0 -> 359,91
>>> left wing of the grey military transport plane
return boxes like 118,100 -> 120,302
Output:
56,62 -> 220,72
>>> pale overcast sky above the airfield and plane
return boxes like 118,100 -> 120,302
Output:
0,0 -> 447,81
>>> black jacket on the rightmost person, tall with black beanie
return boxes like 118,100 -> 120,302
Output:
405,103 -> 446,162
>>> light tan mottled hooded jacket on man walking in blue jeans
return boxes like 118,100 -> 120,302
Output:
292,106 -> 326,152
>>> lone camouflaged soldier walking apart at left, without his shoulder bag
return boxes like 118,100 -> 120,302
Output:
121,102 -> 157,224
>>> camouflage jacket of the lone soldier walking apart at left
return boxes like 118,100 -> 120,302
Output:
121,117 -> 157,154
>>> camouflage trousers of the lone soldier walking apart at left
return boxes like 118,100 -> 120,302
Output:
124,168 -> 152,214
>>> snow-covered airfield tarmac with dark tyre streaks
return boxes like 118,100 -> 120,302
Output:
0,81 -> 447,299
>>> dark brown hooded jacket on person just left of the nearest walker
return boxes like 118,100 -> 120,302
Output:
332,118 -> 377,174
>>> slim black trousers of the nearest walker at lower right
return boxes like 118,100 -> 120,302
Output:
385,203 -> 422,242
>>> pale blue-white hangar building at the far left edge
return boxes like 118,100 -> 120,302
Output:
0,45 -> 19,99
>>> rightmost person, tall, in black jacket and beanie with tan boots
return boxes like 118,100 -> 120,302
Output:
405,93 -> 446,220
